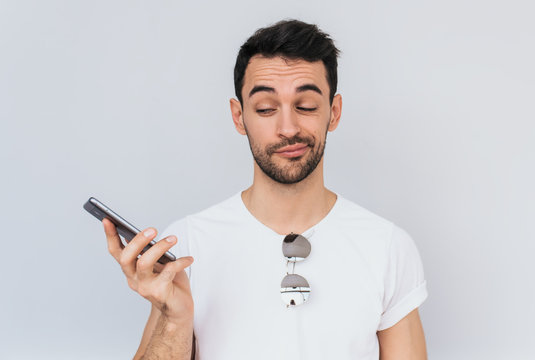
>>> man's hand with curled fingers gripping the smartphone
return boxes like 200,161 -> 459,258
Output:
102,219 -> 193,325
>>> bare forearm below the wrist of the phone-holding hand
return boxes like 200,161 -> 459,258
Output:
141,315 -> 193,360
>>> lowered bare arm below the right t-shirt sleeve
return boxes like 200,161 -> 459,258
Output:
377,309 -> 427,360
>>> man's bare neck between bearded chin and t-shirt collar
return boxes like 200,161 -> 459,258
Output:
242,159 -> 336,235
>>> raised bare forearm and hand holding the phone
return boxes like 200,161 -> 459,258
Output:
102,219 -> 193,360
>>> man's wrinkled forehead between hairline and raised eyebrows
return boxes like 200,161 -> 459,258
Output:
243,55 -> 329,94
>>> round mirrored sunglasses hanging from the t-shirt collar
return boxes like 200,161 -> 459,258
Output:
281,233 -> 312,307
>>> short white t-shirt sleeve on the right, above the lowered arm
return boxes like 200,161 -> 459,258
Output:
377,225 -> 427,330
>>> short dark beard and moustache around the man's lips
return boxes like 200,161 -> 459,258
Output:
245,121 -> 327,184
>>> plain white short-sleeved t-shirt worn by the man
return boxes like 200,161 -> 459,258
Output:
162,193 -> 427,360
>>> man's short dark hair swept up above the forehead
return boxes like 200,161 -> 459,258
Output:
234,20 -> 340,103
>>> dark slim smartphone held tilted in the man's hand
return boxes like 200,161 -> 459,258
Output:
84,197 -> 176,264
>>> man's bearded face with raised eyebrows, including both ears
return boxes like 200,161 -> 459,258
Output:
231,56 -> 341,184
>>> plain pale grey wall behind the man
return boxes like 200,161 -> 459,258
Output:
0,0 -> 535,359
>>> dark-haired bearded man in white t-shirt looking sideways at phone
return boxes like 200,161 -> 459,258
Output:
104,20 -> 427,360
